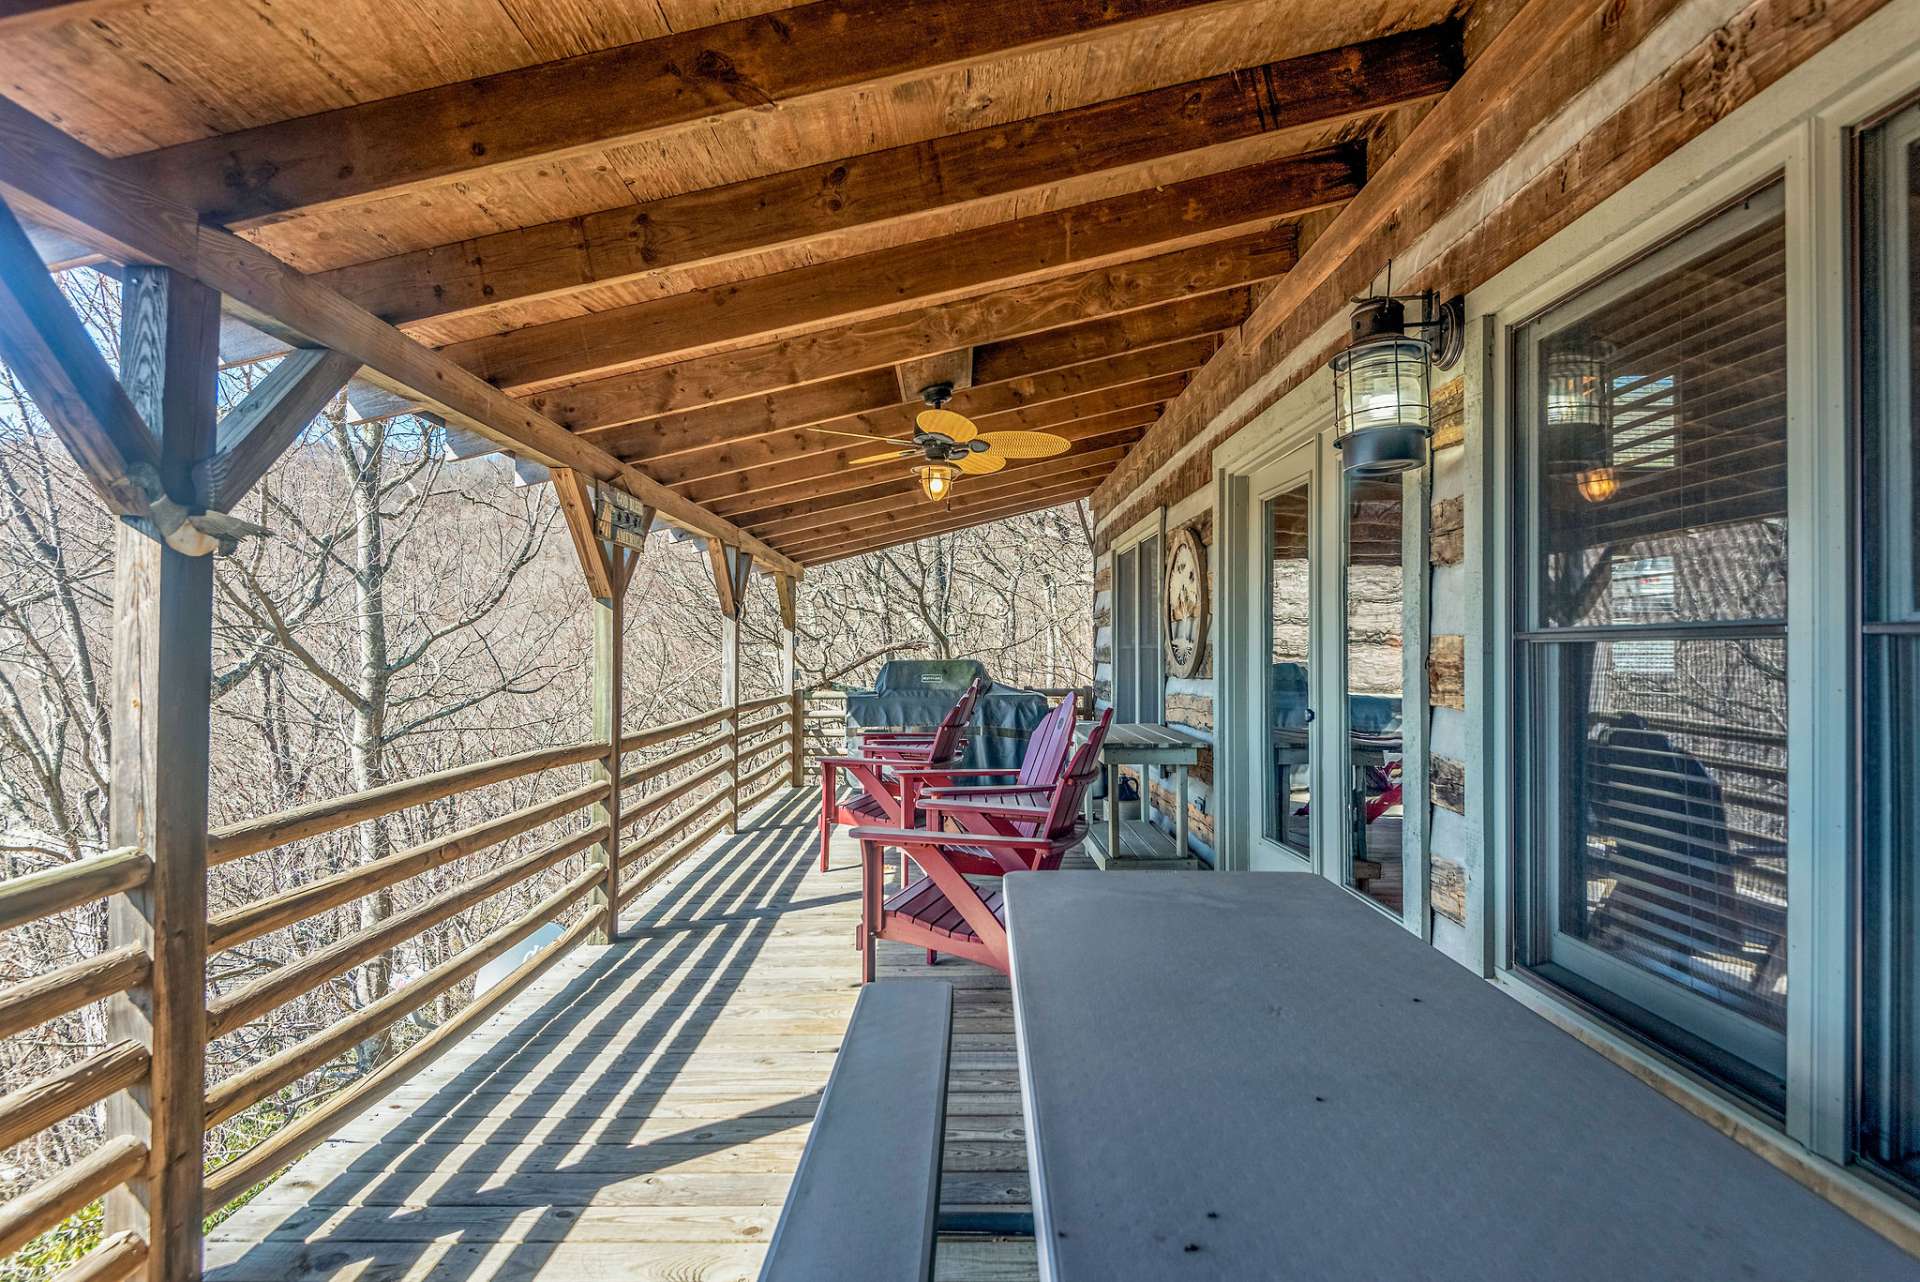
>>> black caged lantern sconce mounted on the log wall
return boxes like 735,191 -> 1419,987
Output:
1332,290 -> 1467,476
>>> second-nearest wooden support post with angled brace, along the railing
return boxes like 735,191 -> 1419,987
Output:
553,468 -> 645,944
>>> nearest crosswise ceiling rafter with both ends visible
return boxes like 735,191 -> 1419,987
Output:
321,25 -> 1461,328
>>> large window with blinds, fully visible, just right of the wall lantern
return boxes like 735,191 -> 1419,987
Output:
1513,184 -> 1788,1111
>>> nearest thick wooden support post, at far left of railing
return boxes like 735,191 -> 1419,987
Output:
106,267 -> 219,1282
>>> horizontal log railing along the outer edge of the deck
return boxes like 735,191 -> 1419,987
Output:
0,691 -> 845,1282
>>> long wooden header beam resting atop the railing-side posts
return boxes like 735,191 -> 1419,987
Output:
0,98 -> 799,572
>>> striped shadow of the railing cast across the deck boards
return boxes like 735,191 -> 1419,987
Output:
209,791 -> 856,1280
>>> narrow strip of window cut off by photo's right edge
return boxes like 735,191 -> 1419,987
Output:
1857,107 -> 1920,1188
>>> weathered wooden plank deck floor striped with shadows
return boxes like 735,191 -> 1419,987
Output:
207,793 -> 1037,1282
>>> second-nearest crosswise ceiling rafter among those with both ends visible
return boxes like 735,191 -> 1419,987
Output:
442,146 -> 1365,390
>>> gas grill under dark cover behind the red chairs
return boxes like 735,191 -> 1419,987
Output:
847,658 -> 1048,772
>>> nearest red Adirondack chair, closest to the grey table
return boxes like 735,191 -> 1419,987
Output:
852,706 -> 1114,983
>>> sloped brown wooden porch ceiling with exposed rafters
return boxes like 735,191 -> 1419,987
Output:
0,0 -> 1461,571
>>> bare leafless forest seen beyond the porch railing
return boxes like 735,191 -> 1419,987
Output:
0,271 -> 1092,1258
